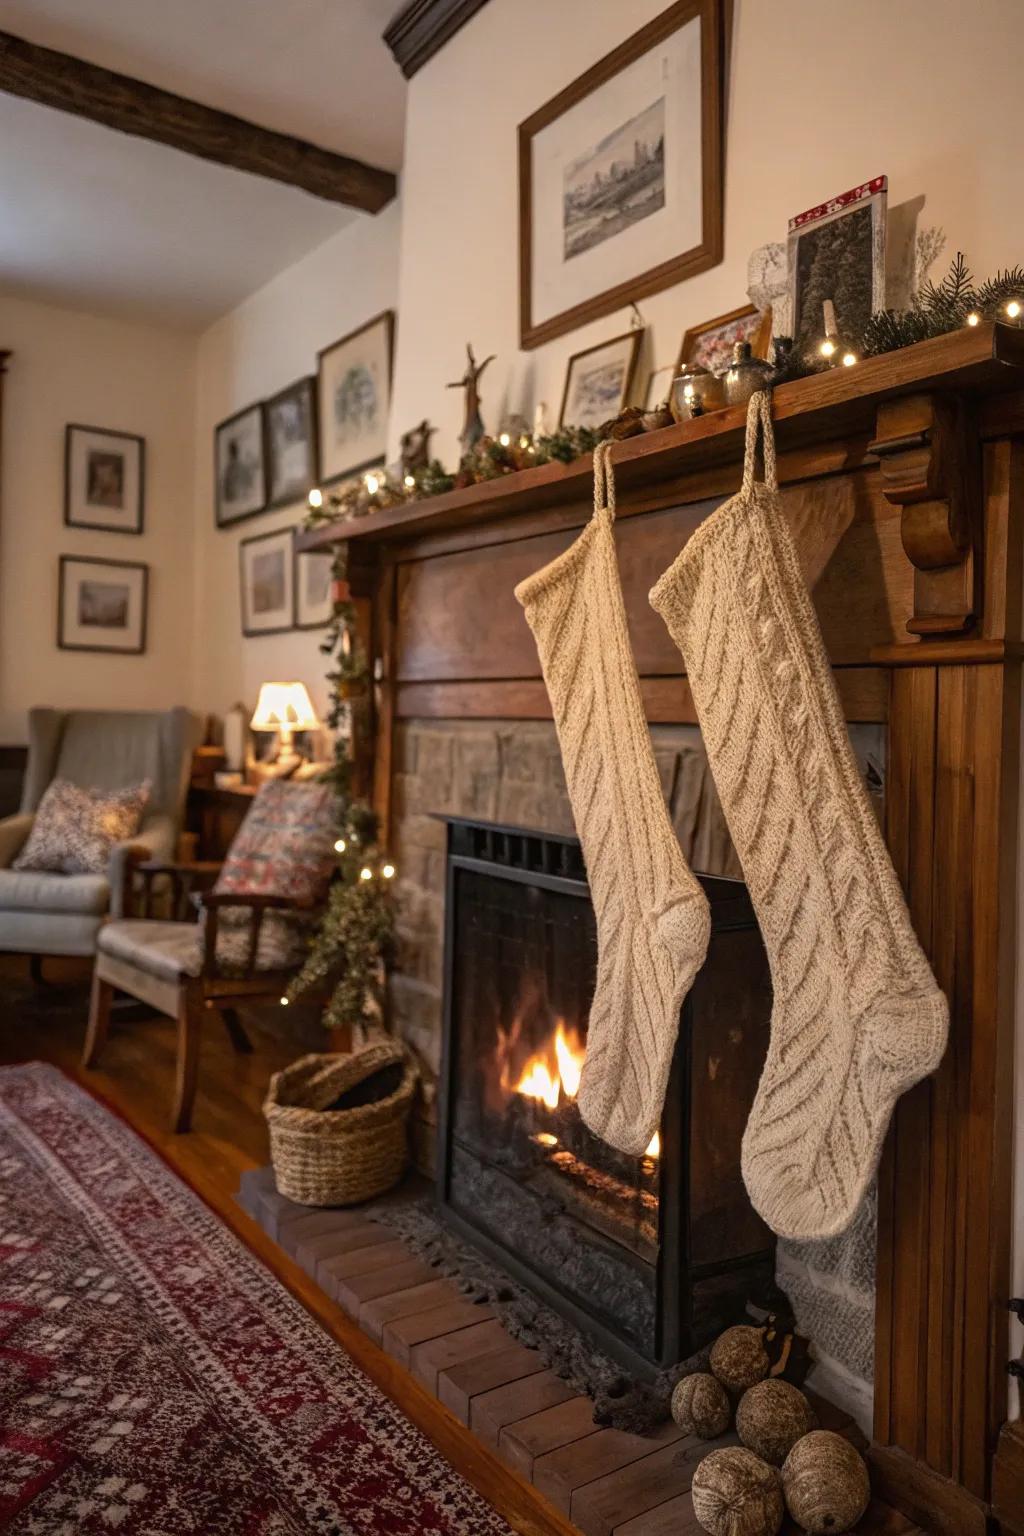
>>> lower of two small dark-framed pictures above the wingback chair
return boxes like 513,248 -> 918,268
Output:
57,554 -> 149,656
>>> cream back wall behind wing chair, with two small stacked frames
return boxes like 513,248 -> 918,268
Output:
0,295 -> 195,743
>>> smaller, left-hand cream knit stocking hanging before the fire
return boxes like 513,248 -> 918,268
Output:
516,444 -> 711,1154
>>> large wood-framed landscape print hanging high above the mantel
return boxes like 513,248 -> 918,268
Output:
519,0 -> 723,347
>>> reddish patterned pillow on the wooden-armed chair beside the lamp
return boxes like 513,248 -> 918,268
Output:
213,779 -> 336,905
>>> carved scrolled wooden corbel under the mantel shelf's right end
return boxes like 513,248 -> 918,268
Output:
869,395 -> 981,634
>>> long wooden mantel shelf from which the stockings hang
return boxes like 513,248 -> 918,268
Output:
298,323 -> 1024,550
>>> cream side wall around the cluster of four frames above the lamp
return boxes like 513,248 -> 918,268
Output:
195,201 -> 401,728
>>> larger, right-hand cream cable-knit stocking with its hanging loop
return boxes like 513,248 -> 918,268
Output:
651,395 -> 947,1238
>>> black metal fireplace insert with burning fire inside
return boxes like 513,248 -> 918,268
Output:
438,817 -> 774,1375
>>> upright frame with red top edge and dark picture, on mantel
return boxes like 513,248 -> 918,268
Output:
789,177 -> 889,356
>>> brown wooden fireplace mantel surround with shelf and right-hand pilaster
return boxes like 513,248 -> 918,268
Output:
310,324 -> 1024,1536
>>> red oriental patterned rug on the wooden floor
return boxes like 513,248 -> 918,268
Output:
0,1064 -> 510,1536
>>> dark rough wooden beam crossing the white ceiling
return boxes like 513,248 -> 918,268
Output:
0,32 -> 398,214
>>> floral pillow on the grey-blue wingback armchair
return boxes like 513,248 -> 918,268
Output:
12,779 -> 152,874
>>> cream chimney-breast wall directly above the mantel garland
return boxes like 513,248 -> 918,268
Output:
391,0 -> 1024,459
